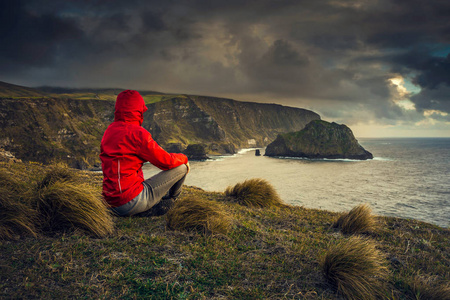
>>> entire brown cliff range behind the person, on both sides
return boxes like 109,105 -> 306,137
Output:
0,85 -> 320,169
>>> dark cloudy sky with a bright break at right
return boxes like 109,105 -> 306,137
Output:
0,0 -> 450,137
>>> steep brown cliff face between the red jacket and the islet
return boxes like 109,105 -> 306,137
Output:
143,96 -> 320,153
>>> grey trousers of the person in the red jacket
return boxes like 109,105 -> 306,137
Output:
111,165 -> 187,216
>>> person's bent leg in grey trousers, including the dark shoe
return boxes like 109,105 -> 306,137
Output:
122,165 -> 187,216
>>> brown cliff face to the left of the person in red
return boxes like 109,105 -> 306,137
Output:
0,98 -> 114,169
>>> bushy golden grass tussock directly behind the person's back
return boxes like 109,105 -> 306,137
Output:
35,181 -> 113,237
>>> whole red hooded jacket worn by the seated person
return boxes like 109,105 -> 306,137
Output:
100,90 -> 188,207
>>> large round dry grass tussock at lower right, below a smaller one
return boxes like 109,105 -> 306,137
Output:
322,236 -> 387,299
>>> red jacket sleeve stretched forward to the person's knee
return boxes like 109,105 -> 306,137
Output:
138,130 -> 188,170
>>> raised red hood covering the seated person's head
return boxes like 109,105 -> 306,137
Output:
114,90 -> 147,125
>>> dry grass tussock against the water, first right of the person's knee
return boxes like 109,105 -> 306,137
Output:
225,178 -> 284,207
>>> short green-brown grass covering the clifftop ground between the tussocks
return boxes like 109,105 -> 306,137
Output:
0,163 -> 450,299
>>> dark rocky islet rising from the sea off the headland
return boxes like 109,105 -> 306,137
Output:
265,120 -> 373,160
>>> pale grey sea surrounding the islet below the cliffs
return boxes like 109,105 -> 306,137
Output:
143,138 -> 450,228
